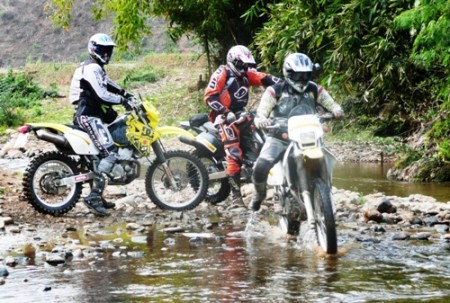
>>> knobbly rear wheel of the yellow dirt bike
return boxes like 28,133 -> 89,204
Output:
22,151 -> 82,216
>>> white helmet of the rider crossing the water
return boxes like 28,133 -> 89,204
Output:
283,53 -> 314,93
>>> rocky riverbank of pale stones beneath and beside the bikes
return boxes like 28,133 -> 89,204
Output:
0,131 -> 450,284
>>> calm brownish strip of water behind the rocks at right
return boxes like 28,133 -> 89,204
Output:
333,163 -> 450,202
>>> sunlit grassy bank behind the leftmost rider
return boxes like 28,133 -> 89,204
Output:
0,54 -> 207,133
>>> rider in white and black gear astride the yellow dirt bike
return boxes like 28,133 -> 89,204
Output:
69,33 -> 131,216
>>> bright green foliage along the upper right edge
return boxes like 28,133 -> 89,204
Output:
395,0 -> 450,161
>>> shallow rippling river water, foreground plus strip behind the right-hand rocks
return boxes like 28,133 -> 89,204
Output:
0,164 -> 450,303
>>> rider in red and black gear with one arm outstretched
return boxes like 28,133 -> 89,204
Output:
205,45 -> 279,206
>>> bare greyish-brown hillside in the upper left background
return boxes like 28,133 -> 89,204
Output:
0,0 -> 190,69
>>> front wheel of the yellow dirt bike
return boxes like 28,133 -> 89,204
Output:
145,150 -> 208,211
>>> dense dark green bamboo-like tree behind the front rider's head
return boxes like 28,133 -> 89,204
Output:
254,0 -> 431,135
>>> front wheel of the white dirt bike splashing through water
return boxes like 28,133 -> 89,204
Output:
313,179 -> 337,254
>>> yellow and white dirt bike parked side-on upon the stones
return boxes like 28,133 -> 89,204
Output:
19,97 -> 208,216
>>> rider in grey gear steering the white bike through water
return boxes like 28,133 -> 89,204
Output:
250,53 -> 344,211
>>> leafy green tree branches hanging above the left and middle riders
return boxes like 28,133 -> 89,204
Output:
47,0 -> 277,70
